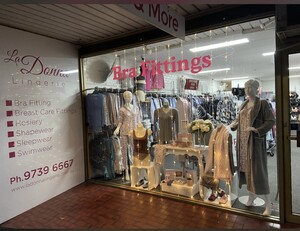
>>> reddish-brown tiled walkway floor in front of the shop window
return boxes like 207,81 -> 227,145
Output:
0,182 -> 300,229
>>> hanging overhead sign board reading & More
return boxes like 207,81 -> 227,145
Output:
119,4 -> 185,39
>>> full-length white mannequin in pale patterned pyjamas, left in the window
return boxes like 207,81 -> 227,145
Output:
114,91 -> 140,180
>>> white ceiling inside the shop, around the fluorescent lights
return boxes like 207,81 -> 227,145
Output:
104,18 -> 275,81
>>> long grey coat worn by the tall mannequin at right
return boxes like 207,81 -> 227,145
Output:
231,97 -> 275,195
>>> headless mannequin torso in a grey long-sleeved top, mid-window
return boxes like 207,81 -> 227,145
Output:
154,99 -> 179,143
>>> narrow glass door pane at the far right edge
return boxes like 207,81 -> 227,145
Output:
289,54 -> 300,214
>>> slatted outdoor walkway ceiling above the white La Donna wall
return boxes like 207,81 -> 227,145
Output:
0,4 -> 228,46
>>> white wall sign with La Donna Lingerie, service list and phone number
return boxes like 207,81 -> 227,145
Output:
0,26 -> 84,223
